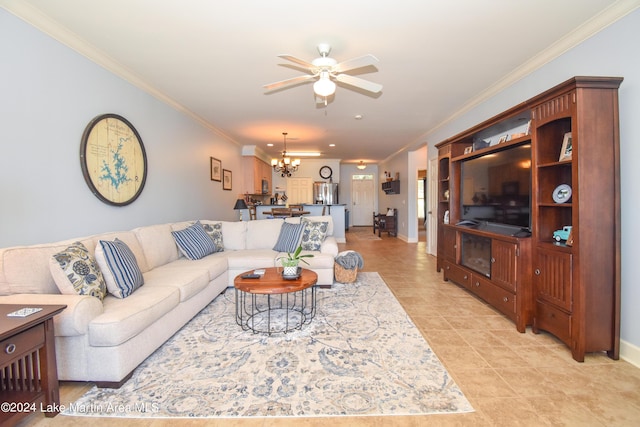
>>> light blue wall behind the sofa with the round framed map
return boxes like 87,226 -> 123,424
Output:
0,9 -> 242,247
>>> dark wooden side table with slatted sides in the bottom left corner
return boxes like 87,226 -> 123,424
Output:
0,304 -> 67,426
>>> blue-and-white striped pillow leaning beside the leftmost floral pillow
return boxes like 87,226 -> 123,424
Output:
96,238 -> 144,298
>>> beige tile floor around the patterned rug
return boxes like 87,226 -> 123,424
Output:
21,227 -> 640,427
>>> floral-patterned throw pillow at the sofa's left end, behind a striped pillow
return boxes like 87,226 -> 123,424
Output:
49,242 -> 107,301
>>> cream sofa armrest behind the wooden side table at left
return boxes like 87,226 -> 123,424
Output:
0,294 -> 103,337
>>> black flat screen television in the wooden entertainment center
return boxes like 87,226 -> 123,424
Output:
460,143 -> 531,229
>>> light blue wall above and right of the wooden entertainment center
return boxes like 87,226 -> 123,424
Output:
427,9 -> 640,347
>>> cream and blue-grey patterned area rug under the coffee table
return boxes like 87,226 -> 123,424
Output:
63,272 -> 473,418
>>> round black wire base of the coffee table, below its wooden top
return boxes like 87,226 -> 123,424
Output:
235,286 -> 316,335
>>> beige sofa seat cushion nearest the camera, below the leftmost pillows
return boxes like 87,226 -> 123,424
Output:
89,286 -> 180,347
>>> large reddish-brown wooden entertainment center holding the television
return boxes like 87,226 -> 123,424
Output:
436,77 -> 623,362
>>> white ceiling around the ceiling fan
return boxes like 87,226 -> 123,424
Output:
0,0 -> 638,162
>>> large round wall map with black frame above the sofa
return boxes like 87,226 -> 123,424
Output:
80,114 -> 147,206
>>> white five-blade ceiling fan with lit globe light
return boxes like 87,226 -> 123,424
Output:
264,43 -> 382,102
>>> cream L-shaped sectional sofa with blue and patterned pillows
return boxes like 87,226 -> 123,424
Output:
0,216 -> 338,387
